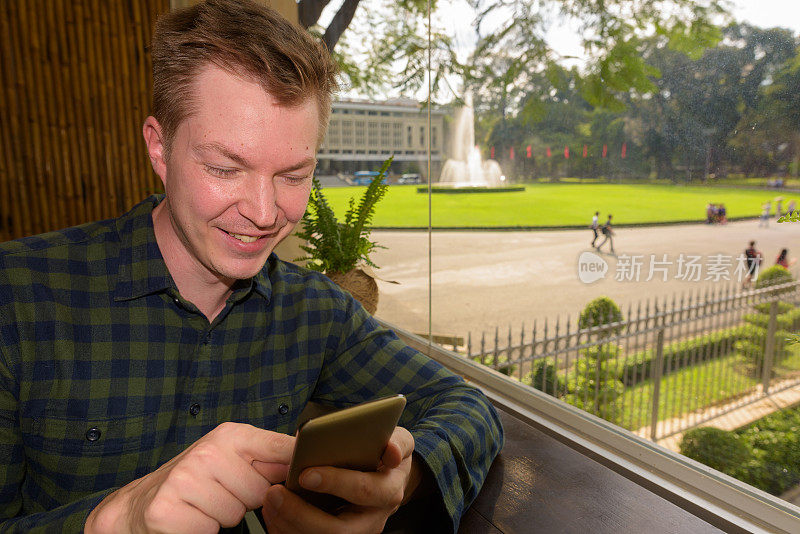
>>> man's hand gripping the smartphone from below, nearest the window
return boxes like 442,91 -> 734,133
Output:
262,427 -> 422,534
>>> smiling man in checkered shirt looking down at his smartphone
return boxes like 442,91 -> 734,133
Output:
0,0 -> 502,534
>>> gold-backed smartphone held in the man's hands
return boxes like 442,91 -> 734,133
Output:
286,395 -> 406,513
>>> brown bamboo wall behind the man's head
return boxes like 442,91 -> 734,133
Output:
0,0 -> 169,241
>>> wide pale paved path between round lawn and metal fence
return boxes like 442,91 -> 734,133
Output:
373,221 -> 800,336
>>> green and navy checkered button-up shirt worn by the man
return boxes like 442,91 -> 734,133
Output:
0,197 -> 503,532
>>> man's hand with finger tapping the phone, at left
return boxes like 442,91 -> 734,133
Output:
85,423 -> 295,534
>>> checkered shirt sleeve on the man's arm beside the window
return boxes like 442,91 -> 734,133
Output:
312,301 -> 503,532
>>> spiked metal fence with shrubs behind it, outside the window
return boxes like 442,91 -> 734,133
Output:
466,282 -> 800,441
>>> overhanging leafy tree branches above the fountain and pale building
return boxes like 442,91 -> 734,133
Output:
298,0 -> 724,101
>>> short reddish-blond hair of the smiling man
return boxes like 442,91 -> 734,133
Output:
152,0 -> 338,157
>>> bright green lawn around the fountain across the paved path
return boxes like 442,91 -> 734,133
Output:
324,184 -> 800,227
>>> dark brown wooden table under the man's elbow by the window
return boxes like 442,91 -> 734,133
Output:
386,411 -> 723,534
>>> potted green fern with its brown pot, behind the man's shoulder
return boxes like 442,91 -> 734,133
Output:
297,158 -> 392,313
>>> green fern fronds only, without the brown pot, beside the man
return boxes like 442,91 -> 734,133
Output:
296,157 -> 392,273
